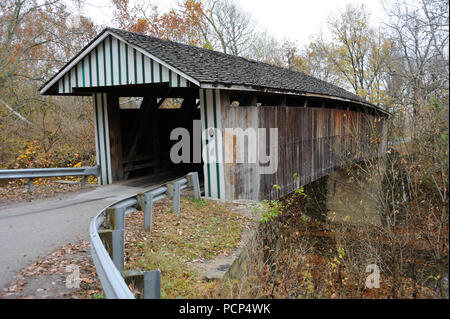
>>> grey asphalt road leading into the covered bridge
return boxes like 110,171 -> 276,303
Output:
0,175 -> 183,289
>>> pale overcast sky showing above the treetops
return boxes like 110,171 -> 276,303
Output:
69,0 -> 390,46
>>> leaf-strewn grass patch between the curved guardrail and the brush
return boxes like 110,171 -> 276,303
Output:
125,198 -> 248,298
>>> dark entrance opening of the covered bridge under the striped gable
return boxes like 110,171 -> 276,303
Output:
90,84 -> 203,188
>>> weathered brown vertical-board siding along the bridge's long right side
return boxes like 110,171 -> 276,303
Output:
222,103 -> 379,200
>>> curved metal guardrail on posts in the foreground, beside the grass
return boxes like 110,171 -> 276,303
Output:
89,172 -> 200,299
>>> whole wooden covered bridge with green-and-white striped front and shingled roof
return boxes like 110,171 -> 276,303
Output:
40,28 -> 387,200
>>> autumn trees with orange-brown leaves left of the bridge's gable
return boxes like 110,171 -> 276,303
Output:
0,0 -> 97,167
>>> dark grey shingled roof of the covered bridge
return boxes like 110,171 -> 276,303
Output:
39,28 -> 384,112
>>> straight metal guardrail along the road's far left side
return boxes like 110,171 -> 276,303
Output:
0,165 -> 99,191
